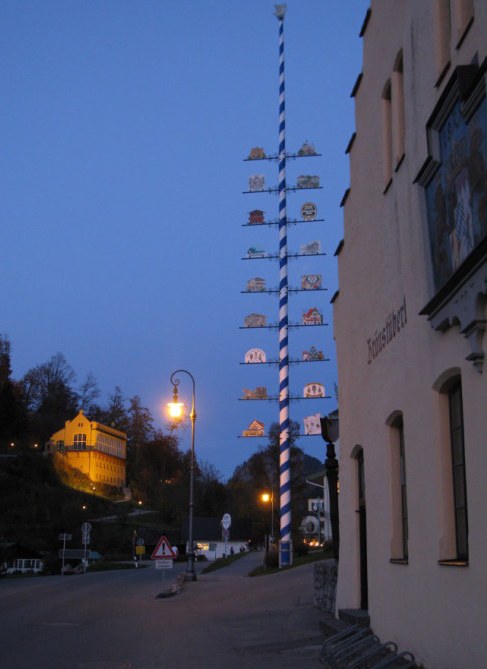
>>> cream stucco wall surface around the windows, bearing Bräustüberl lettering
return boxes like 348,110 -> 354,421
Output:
334,0 -> 487,669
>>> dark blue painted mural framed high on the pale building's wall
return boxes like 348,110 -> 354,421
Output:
426,93 -> 487,290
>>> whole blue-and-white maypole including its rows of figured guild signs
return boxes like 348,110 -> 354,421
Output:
241,4 -> 326,567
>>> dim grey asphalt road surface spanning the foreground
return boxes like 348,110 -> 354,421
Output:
0,553 -> 323,669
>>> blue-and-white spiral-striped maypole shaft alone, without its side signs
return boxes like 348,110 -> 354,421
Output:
275,5 -> 292,567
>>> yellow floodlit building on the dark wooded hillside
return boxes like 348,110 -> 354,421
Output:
49,411 -> 127,487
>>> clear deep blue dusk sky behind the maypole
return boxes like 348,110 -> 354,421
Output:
0,0 -> 369,478
